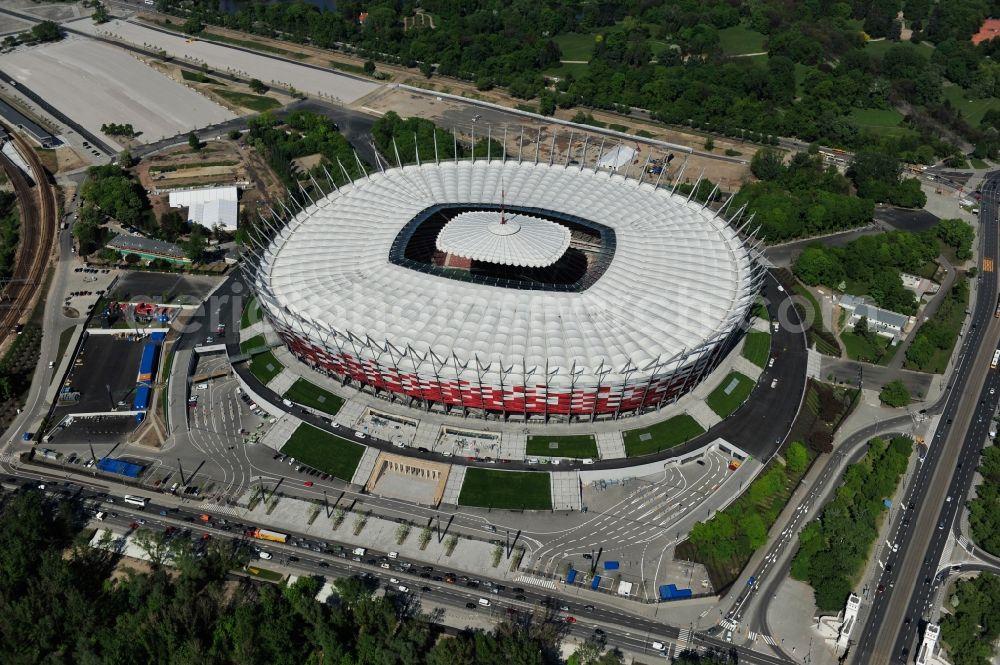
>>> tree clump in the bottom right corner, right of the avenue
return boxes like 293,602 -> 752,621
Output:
941,573 -> 1000,665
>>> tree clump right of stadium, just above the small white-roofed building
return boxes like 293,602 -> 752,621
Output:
794,231 -> 939,314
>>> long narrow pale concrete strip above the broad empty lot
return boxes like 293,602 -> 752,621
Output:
70,20 -> 380,105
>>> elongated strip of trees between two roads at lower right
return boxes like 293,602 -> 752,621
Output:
791,436 -> 913,611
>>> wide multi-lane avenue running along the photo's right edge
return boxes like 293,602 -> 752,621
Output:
853,173 -> 1000,665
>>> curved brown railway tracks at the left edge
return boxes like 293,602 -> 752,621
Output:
0,123 -> 57,341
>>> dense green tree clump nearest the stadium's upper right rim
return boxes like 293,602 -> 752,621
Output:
730,149 -> 875,242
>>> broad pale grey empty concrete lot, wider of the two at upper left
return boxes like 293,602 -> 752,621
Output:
0,36 -> 235,145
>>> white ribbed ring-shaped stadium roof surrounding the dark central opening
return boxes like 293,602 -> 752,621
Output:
262,161 -> 754,386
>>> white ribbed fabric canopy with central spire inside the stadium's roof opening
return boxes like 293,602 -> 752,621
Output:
437,210 -> 570,268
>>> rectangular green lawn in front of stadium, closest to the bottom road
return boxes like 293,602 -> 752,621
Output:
458,467 -> 552,510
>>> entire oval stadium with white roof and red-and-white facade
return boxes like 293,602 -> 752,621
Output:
249,154 -> 763,421
